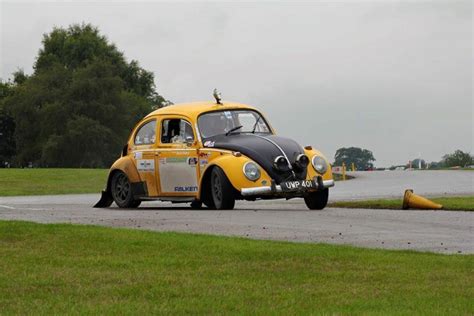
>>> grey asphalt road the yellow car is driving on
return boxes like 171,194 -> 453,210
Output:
0,171 -> 474,253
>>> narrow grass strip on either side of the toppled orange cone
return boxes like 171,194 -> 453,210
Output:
329,196 -> 474,211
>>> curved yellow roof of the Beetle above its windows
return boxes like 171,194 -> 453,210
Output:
146,101 -> 257,120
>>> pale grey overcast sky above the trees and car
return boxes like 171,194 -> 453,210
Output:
0,0 -> 474,166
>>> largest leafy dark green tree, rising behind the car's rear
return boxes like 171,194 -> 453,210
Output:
4,24 -> 169,167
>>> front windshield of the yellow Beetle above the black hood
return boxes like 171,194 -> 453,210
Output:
198,110 -> 271,138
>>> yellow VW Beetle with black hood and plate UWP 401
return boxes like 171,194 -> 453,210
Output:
95,92 -> 334,209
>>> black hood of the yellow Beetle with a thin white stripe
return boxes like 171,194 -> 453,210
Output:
204,134 -> 306,184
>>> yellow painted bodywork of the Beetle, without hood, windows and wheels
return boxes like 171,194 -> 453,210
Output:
104,101 -> 332,200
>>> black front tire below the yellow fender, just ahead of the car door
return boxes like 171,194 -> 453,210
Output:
211,166 -> 235,210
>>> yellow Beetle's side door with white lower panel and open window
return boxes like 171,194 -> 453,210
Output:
155,116 -> 199,197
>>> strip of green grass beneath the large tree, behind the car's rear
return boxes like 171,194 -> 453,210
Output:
0,168 -> 108,196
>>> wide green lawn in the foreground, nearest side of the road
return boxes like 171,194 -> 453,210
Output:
0,221 -> 474,315
